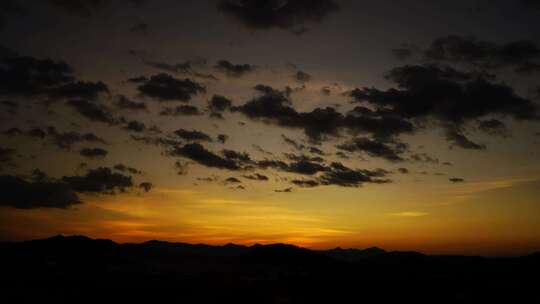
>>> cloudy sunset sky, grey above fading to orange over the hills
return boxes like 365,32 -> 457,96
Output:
0,0 -> 540,256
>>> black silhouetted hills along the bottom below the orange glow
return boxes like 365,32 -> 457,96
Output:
0,236 -> 540,304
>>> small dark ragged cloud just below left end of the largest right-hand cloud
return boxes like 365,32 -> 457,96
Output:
337,138 -> 407,162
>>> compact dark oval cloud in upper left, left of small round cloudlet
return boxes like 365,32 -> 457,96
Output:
130,73 -> 206,102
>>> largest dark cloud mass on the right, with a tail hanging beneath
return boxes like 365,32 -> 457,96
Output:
350,66 -> 538,149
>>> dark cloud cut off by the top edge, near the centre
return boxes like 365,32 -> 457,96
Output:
218,0 -> 339,34
